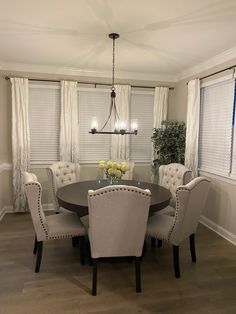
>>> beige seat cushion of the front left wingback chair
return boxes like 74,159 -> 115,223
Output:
47,213 -> 86,239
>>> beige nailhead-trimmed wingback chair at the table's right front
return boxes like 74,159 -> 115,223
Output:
146,177 -> 210,278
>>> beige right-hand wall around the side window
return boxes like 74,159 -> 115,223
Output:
168,59 -> 236,240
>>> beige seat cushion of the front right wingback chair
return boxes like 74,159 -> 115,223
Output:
146,213 -> 174,240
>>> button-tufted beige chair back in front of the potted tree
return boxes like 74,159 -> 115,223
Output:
159,163 -> 192,207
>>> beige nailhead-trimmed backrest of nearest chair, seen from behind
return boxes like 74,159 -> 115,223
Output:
88,185 -> 151,258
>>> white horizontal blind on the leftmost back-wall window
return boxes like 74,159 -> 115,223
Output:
29,84 -> 60,164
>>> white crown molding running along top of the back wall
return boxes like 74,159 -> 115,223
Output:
0,62 -> 175,83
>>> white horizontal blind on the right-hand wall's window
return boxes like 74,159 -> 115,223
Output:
199,79 -> 234,176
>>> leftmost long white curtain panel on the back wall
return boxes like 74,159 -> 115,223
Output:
11,78 -> 30,212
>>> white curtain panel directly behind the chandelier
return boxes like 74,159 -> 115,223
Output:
111,85 -> 131,160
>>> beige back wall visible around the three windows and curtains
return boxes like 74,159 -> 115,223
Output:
0,72 -> 175,214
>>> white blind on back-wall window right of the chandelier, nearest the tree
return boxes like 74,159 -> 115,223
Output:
130,91 -> 154,162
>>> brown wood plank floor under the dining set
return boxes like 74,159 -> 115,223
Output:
0,214 -> 236,314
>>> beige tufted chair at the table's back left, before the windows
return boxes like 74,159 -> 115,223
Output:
46,161 -> 80,213
